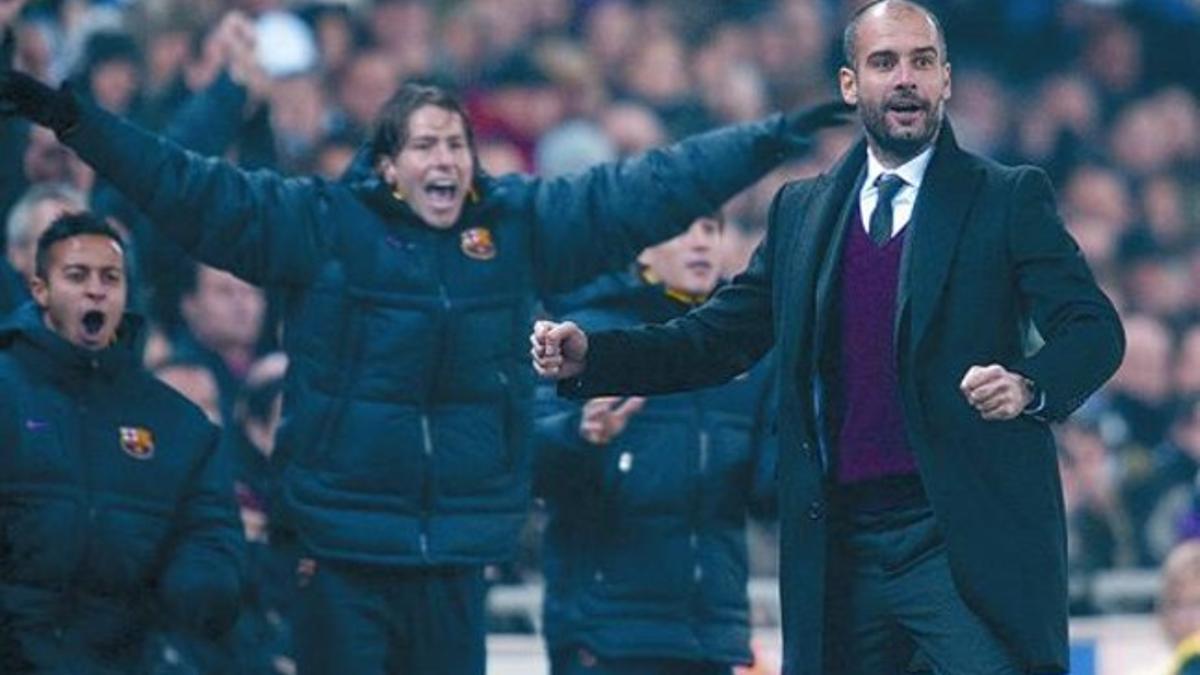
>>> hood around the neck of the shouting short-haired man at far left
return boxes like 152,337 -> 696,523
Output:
0,300 -> 144,376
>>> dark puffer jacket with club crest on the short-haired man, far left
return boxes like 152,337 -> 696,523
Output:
0,303 -> 241,673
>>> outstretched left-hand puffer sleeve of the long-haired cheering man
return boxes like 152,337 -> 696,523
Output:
62,103 -> 330,285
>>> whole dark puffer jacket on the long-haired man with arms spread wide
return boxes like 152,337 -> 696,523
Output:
64,99 -> 798,566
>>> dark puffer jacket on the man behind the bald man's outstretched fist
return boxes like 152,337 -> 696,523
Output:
534,275 -> 776,664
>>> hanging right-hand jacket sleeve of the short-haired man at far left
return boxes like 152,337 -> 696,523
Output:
158,428 -> 244,635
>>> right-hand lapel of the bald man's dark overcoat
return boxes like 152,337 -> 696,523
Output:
895,123 -> 979,356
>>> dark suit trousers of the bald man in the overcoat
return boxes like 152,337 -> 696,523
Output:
824,504 -> 1022,675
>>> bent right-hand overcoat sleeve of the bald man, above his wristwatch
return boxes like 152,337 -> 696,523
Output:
1008,168 -> 1124,420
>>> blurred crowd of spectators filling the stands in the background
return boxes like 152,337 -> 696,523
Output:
0,0 -> 1200,633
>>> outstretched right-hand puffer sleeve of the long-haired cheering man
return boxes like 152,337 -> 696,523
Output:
529,115 -> 797,294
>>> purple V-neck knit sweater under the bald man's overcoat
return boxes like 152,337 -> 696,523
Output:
838,209 -> 917,484
